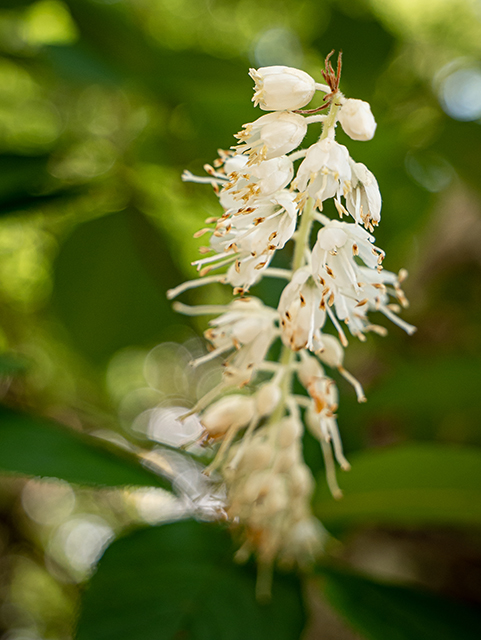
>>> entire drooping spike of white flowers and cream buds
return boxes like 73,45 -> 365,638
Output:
169,57 -> 415,596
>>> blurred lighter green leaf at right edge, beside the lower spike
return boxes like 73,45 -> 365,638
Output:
315,443 -> 481,529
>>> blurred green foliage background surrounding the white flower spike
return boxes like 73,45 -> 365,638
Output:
0,0 -> 481,640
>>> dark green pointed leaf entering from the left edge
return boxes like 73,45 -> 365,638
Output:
0,407 -> 170,489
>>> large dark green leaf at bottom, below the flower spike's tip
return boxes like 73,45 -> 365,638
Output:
77,521 -> 304,640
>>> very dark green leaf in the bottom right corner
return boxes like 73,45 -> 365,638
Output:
321,569 -> 481,640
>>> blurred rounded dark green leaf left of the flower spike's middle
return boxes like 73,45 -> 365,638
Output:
53,208 -> 183,362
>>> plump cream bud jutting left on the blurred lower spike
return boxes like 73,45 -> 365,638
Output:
201,395 -> 255,437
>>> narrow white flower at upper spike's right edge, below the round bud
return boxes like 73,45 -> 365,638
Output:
346,161 -> 382,231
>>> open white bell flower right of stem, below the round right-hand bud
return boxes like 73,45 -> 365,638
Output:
294,138 -> 351,210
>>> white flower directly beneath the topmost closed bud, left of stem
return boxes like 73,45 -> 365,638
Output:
235,111 -> 307,164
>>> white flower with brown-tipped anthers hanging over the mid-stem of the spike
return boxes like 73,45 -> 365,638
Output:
278,268 -> 326,351
